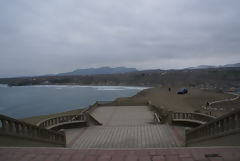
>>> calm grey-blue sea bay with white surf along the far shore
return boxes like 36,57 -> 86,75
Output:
0,84 -> 148,119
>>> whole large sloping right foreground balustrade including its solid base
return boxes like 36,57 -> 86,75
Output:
186,109 -> 240,146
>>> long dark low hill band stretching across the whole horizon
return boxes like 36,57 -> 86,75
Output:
0,67 -> 240,89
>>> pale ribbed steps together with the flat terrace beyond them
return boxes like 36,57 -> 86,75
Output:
65,106 -> 185,149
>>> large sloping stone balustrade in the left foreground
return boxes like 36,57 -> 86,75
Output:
0,115 -> 66,147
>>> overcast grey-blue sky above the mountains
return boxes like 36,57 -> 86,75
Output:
0,0 -> 240,77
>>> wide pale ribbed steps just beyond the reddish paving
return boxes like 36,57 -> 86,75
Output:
65,124 -> 185,149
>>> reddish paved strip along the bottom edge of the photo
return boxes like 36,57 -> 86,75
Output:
0,147 -> 240,161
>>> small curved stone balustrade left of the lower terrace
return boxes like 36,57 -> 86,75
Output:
37,114 -> 87,129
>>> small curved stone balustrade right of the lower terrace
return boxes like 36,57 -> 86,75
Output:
170,112 -> 215,124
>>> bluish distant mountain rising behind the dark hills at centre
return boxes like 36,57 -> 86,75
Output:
57,67 -> 137,76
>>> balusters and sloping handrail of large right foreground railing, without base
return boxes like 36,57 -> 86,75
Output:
186,109 -> 240,143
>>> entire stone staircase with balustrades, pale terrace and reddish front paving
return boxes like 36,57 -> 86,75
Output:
0,106 -> 240,161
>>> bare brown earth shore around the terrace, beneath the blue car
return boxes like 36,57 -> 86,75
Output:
21,87 -> 232,124
